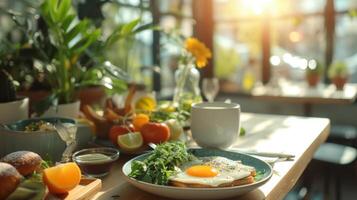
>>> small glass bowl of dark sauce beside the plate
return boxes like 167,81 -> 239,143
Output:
72,147 -> 119,178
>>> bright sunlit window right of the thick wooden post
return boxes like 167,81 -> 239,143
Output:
214,0 -> 357,92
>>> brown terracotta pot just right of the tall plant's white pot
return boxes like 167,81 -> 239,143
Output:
78,86 -> 106,107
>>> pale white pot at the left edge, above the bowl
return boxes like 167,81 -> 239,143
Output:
0,97 -> 29,123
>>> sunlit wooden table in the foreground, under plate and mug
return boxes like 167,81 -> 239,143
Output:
94,113 -> 330,200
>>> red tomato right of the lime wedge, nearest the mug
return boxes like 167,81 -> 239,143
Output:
141,122 -> 170,144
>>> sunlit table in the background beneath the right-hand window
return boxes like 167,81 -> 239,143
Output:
251,82 -> 357,116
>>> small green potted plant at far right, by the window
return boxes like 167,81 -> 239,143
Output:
328,61 -> 349,90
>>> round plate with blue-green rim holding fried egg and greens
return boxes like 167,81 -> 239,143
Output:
122,149 -> 273,199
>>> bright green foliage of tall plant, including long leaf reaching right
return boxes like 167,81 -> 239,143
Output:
41,0 -> 151,107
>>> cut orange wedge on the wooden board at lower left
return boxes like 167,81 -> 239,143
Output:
42,162 -> 82,194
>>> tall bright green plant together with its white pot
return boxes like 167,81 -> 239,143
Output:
38,0 -> 133,118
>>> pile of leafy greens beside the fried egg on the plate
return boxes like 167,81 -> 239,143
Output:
129,141 -> 194,185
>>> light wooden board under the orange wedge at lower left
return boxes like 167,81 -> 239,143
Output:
46,178 -> 102,200
